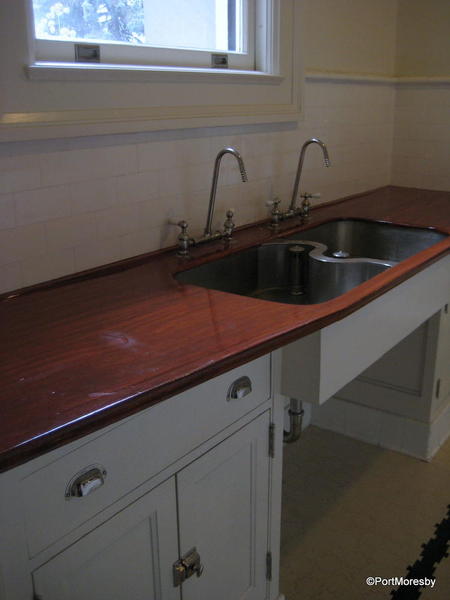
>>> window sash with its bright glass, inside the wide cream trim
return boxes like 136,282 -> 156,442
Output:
32,0 -> 256,71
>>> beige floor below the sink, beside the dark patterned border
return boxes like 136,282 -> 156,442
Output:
280,427 -> 450,600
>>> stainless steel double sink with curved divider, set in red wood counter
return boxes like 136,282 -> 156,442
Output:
175,220 -> 446,305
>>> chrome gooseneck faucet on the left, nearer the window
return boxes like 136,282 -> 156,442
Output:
170,147 -> 248,257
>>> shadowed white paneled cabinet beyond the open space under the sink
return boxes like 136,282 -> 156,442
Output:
312,304 -> 450,460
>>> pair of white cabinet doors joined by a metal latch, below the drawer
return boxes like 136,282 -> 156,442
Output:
33,411 -> 270,600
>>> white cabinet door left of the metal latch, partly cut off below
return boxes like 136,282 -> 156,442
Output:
33,477 -> 180,600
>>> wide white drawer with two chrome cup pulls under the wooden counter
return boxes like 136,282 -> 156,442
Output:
21,355 -> 270,557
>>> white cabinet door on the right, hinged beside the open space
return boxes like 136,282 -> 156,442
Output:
177,411 -> 270,600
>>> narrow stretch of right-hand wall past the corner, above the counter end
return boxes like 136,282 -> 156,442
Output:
392,0 -> 450,190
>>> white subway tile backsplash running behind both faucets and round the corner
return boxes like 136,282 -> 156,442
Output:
4,81 -> 450,296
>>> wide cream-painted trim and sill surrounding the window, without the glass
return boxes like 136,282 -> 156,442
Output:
0,0 -> 303,141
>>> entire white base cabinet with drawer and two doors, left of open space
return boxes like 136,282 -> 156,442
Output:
0,355 -> 283,600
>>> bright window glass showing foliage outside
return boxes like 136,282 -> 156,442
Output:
33,0 -> 244,52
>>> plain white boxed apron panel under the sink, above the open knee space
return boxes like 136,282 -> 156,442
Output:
281,256 -> 450,404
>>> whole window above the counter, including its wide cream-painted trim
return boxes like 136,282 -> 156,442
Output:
0,0 -> 304,141
